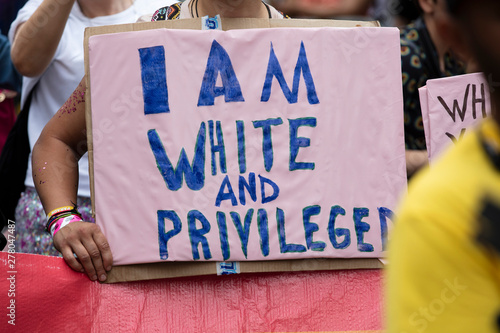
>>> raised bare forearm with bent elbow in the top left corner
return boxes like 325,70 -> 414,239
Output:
11,0 -> 75,76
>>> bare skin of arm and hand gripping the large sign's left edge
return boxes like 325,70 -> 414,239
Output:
32,79 -> 113,281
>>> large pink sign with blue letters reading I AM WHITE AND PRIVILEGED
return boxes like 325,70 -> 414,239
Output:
89,28 -> 406,265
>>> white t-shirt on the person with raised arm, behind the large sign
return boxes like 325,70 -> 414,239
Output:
9,0 -> 170,197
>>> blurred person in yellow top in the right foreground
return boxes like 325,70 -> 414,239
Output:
386,0 -> 500,333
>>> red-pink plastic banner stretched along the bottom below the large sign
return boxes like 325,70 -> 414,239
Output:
0,252 -> 383,333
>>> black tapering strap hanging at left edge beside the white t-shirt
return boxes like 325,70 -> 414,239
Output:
0,83 -> 38,230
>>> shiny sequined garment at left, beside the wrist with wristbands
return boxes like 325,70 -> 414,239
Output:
15,186 -> 94,256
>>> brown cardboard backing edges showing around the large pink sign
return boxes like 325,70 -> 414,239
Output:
84,18 -> 384,283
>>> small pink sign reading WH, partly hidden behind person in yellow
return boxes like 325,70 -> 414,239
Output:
419,73 -> 491,162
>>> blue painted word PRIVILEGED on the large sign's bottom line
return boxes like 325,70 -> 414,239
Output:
157,205 -> 394,261
